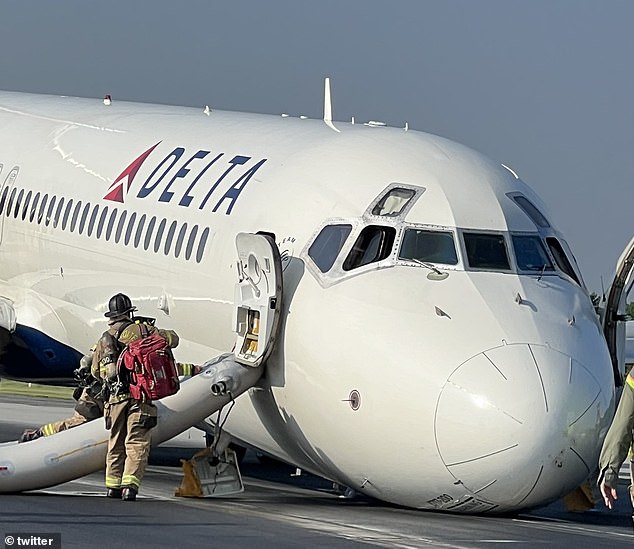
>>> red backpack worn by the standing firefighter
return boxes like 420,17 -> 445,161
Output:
119,324 -> 180,400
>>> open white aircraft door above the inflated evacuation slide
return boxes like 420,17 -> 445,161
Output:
234,233 -> 282,366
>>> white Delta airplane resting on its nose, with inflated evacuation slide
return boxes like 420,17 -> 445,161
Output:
0,80 -> 634,513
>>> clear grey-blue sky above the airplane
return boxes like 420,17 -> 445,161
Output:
0,0 -> 634,299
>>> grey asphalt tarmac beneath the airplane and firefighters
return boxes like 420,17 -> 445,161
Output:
0,396 -> 634,549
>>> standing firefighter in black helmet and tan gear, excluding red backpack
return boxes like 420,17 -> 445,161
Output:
92,293 -> 178,501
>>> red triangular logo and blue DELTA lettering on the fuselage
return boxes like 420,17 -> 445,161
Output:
104,141 -> 267,215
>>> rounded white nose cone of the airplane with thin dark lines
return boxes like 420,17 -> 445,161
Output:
435,344 -> 610,511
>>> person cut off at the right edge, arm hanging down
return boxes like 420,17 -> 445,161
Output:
599,371 -> 634,509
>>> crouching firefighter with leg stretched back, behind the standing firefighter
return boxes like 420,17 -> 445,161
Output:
19,350 -> 103,442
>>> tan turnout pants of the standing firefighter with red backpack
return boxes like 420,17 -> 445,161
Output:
104,398 -> 156,491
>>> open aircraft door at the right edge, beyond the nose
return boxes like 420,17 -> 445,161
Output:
603,238 -> 634,387
